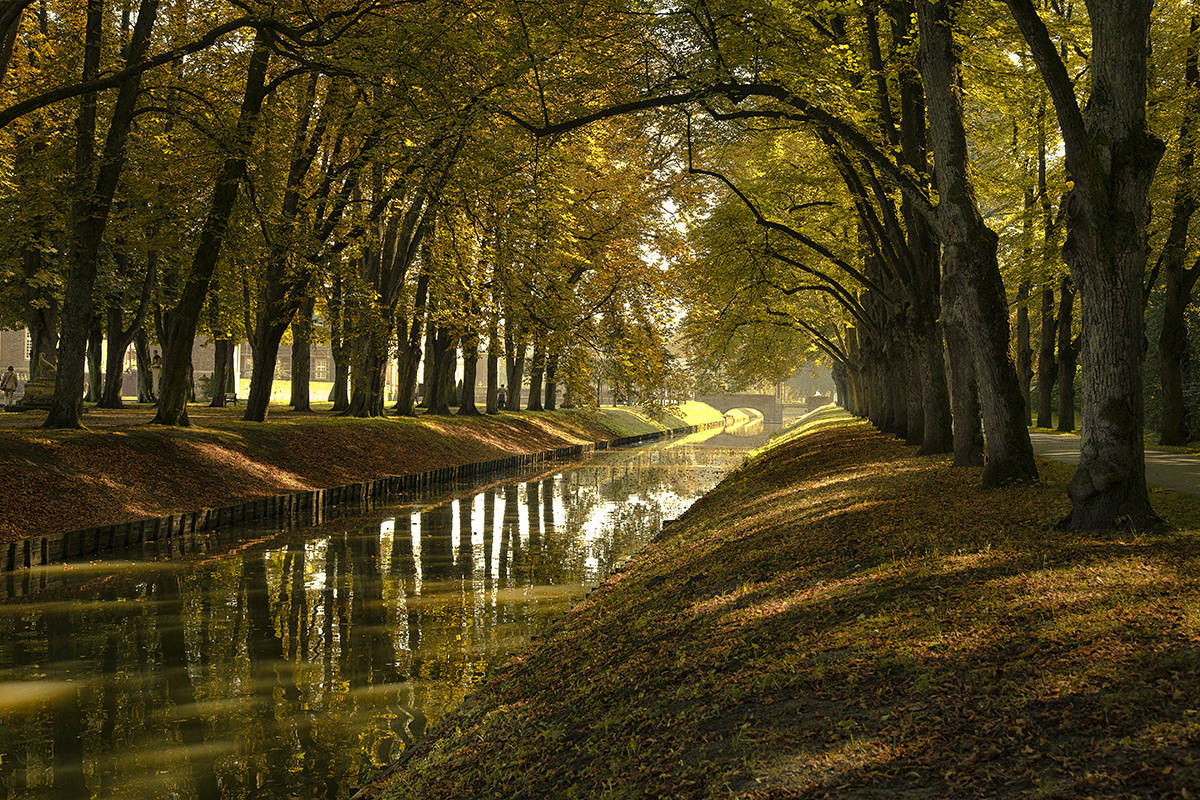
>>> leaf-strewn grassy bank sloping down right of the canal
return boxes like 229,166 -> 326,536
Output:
368,413 -> 1200,799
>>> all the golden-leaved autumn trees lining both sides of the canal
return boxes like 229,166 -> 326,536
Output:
0,0 -> 1200,528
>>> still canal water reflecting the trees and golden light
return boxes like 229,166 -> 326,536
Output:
0,422 -> 766,800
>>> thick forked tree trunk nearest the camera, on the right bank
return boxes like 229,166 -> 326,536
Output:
1007,0 -> 1165,530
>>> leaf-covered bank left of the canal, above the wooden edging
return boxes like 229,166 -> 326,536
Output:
0,403 -> 722,542
